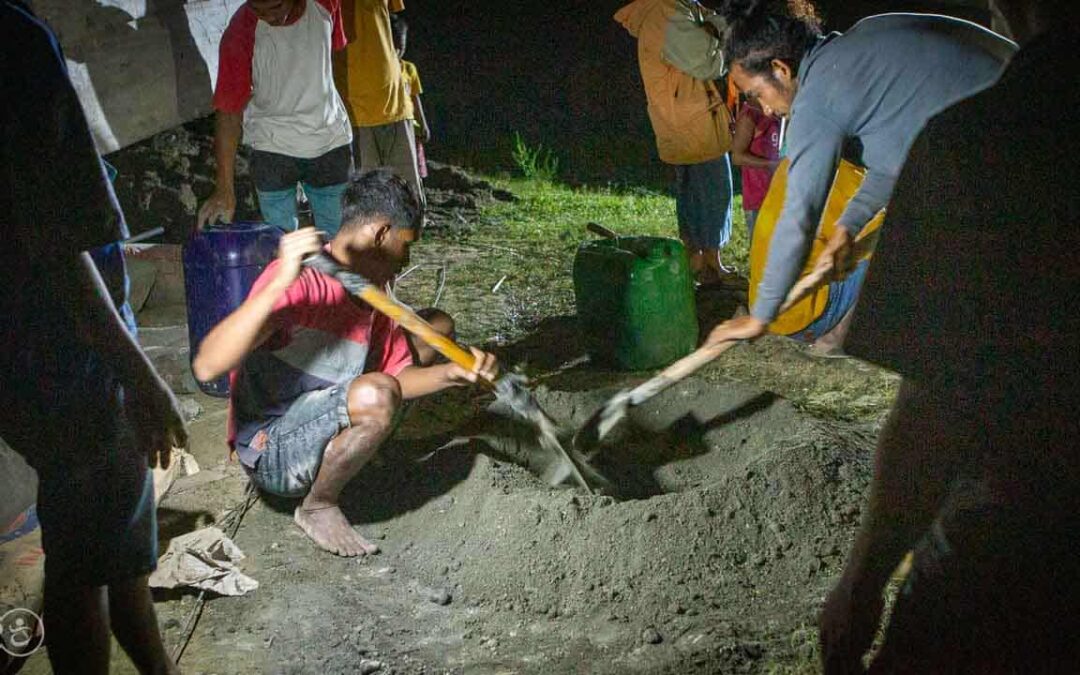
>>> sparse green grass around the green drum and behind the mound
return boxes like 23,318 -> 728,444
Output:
403,177 -> 899,422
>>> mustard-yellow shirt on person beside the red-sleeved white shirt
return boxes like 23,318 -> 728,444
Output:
334,0 -> 413,126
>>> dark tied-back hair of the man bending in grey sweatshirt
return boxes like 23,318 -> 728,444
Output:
718,0 -> 822,79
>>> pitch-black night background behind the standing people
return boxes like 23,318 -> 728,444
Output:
403,0 -> 989,187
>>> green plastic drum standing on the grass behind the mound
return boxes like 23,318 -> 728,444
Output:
573,237 -> 698,370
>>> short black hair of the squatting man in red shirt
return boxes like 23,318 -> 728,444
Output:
341,168 -> 423,231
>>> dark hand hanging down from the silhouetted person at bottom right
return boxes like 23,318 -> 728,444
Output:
819,579 -> 883,675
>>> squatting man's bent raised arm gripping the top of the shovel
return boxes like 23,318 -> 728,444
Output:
191,228 -> 322,382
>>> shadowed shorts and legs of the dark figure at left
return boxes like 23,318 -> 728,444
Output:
27,388 -> 175,673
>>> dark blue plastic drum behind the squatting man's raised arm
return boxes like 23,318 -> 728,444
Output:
184,222 -> 282,396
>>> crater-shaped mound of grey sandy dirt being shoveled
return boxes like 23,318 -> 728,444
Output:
384,382 -> 870,672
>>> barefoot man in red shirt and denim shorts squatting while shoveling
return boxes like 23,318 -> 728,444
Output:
191,170 -> 498,556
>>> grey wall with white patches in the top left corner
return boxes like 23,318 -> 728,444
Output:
30,0 -> 243,153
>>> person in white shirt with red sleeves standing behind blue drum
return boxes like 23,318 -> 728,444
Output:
198,0 -> 352,234
